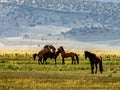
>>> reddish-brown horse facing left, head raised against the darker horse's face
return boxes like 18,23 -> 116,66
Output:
58,46 -> 79,64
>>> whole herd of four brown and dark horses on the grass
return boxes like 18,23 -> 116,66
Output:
33,44 -> 103,74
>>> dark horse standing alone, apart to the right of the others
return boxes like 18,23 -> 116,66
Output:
84,51 -> 103,74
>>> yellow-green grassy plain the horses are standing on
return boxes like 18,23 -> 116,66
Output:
0,50 -> 120,90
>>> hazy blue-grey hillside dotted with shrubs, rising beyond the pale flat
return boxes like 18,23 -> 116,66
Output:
0,0 -> 120,49
